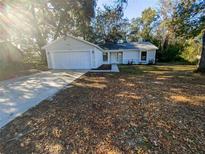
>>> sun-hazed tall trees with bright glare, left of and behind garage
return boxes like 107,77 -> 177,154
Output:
0,0 -> 96,62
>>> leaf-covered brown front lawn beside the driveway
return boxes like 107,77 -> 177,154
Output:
0,65 -> 205,154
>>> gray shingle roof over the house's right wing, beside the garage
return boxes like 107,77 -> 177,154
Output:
100,42 -> 158,50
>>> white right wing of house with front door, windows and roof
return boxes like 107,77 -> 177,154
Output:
101,42 -> 158,64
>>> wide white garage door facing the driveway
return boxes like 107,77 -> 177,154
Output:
51,51 -> 91,69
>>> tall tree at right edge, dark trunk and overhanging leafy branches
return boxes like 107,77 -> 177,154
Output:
173,0 -> 205,72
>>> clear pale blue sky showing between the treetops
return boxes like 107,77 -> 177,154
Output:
97,0 -> 158,19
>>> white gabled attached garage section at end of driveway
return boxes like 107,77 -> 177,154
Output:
43,36 -> 103,69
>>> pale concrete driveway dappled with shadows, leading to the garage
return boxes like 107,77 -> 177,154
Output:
0,70 -> 87,128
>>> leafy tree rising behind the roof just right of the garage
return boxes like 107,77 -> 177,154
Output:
92,3 -> 128,44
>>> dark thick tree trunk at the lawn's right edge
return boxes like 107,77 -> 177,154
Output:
197,31 -> 205,72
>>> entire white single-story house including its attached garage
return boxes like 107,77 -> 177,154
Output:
43,36 -> 158,69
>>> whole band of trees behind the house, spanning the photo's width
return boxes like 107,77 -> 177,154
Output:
0,0 -> 205,71
